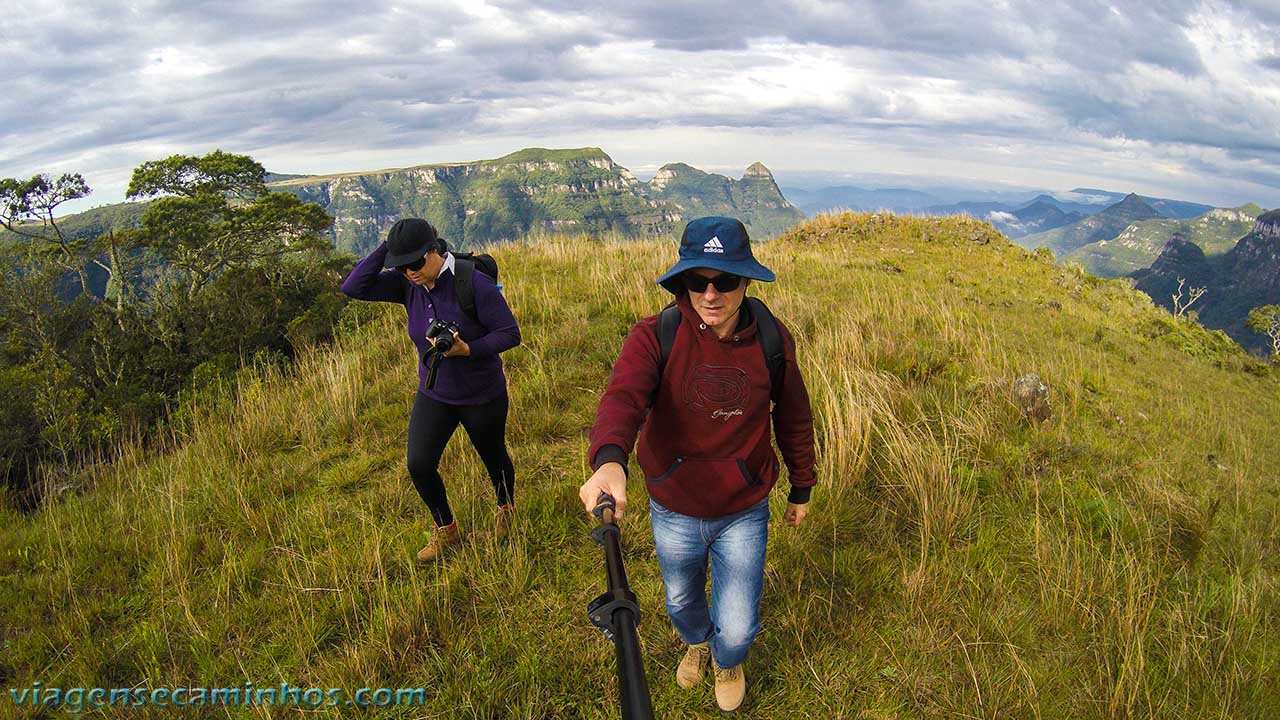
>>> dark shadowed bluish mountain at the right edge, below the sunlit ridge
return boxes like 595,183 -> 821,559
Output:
1132,210 -> 1280,351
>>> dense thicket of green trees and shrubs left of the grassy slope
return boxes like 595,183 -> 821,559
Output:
0,151 -> 352,506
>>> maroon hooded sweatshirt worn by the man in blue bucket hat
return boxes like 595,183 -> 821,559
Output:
588,295 -> 817,518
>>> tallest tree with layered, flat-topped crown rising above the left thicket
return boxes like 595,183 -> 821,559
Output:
128,150 -> 333,300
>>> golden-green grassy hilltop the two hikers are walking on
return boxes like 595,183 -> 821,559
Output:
0,210 -> 1280,719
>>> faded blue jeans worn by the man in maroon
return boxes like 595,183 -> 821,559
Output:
649,497 -> 769,667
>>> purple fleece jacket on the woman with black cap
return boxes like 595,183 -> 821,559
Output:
342,242 -> 520,397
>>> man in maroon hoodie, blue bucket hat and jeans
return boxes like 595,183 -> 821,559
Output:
579,218 -> 815,711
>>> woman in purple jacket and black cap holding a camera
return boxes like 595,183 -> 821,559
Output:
342,218 -> 520,562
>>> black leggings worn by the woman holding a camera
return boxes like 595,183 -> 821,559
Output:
407,392 -> 516,525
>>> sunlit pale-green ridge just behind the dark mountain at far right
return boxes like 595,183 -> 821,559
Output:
1062,205 -> 1263,278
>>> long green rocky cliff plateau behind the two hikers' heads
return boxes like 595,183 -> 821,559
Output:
273,147 -> 804,254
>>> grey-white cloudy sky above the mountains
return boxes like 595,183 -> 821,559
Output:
0,0 -> 1280,208
